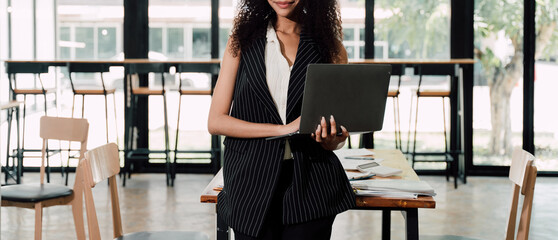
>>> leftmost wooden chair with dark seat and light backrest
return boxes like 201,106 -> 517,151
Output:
2,116 -> 89,240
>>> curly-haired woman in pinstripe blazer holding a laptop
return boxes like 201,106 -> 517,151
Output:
208,0 -> 355,240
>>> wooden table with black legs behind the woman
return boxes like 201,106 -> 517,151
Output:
200,150 -> 436,240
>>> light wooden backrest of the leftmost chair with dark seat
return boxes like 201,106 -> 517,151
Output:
40,116 -> 89,184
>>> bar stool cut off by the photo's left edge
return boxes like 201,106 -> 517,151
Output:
0,101 -> 22,185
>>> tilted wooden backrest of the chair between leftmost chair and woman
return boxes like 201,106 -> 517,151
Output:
76,143 -> 122,240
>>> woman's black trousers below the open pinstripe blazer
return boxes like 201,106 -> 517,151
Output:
234,160 -> 335,240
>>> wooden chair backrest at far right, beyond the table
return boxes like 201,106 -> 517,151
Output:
506,148 -> 537,240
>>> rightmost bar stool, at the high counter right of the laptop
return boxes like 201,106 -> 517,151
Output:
407,64 -> 457,188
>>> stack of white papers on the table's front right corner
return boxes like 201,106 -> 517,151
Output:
351,179 -> 436,198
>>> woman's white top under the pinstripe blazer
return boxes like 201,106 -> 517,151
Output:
265,23 -> 293,159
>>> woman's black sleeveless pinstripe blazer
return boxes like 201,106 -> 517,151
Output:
217,29 -> 355,236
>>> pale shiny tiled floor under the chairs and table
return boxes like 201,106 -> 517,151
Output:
1,173 -> 558,240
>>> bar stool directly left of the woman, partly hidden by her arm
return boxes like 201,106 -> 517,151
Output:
171,64 -> 214,184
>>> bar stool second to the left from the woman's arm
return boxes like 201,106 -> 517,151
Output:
122,63 -> 172,186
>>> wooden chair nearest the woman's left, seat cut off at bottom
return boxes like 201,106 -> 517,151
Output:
76,143 -> 209,240
